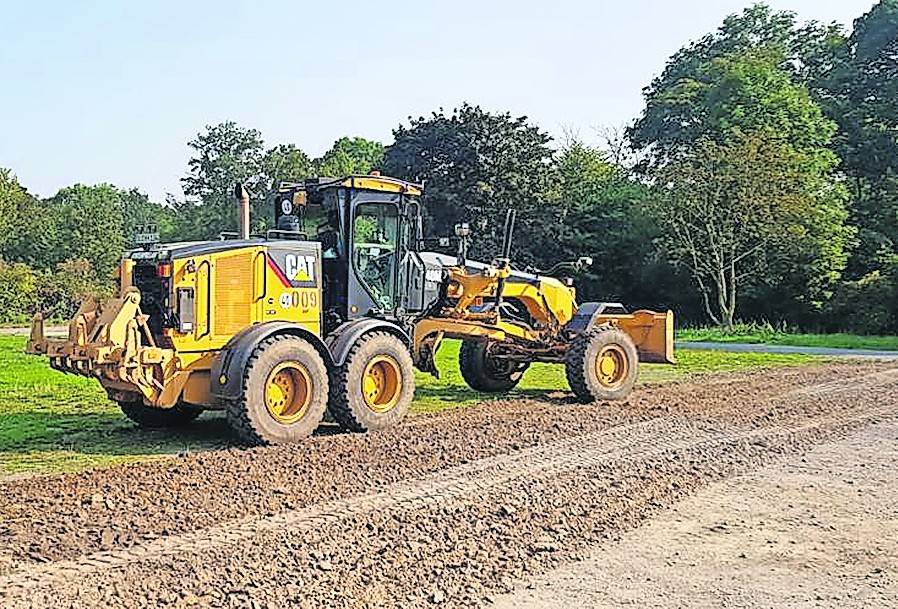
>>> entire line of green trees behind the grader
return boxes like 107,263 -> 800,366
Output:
0,0 -> 898,333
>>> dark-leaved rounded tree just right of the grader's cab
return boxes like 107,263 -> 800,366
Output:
384,104 -> 558,263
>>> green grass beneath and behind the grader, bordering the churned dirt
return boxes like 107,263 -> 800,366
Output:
0,336 -> 817,477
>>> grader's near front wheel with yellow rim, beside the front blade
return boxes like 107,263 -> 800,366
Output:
564,326 -> 639,404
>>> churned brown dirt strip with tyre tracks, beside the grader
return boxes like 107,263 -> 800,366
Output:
0,362 -> 898,607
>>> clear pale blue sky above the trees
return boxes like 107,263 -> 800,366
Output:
0,0 -> 873,200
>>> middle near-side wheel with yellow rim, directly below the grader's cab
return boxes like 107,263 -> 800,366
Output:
329,332 -> 415,432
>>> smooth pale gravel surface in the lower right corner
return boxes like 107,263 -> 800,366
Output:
495,416 -> 898,609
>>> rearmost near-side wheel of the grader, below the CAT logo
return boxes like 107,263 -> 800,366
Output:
225,335 -> 328,445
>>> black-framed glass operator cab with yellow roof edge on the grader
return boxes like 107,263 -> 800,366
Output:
275,175 -> 439,334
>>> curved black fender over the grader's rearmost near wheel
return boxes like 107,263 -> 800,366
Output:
210,321 -> 333,400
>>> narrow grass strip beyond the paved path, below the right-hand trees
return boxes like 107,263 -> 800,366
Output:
677,324 -> 898,351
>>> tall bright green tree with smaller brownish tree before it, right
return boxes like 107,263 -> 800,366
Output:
629,5 -> 854,325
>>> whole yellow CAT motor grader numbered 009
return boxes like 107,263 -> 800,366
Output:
27,175 -> 673,444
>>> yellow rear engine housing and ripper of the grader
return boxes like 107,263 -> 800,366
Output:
27,244 -> 322,408
